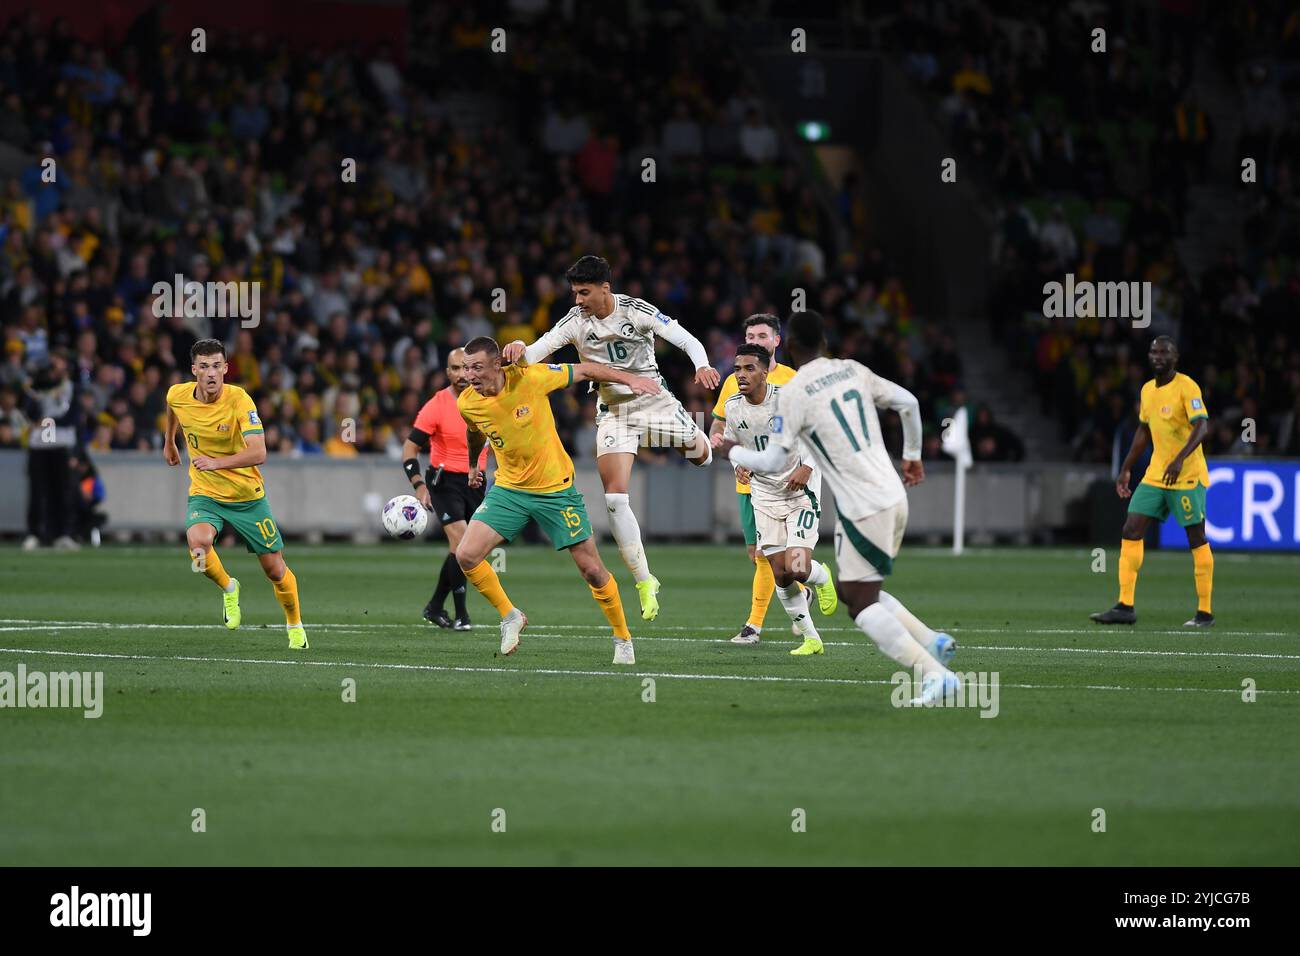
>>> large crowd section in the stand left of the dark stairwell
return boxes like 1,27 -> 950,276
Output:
0,3 -> 961,530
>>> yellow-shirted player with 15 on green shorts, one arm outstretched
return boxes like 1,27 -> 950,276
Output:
456,336 -> 659,663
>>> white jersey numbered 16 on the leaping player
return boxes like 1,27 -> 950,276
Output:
524,295 -> 685,403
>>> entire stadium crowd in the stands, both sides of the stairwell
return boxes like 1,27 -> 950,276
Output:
0,1 -> 1300,554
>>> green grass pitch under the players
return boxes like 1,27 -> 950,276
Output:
0,542 -> 1300,865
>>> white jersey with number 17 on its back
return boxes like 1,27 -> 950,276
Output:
772,359 -> 920,520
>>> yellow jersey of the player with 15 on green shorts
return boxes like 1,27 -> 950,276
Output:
456,365 -> 573,494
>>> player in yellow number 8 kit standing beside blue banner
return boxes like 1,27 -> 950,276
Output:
1091,336 -> 1214,627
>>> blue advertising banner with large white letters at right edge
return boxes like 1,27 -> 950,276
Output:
1160,459 -> 1300,551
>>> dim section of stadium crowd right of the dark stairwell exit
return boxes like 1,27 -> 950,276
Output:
888,0 -> 1300,462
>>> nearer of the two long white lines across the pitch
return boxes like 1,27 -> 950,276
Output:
0,648 -> 1300,695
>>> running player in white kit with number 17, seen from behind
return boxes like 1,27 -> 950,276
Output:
722,312 -> 959,704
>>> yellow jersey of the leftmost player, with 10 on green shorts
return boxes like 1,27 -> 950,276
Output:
166,381 -> 267,501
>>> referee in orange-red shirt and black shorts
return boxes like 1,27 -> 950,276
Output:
402,349 -> 488,631
